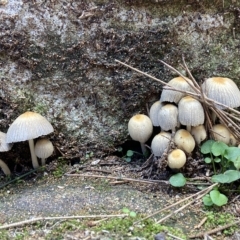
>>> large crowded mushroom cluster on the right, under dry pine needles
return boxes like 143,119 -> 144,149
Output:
128,76 -> 240,169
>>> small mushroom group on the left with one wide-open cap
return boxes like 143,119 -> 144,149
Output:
0,111 -> 54,175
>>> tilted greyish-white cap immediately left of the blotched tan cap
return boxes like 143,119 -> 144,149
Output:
151,132 -> 171,157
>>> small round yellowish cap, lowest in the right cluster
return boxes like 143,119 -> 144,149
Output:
168,149 -> 186,169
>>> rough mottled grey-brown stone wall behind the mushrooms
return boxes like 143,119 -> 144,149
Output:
0,0 -> 240,157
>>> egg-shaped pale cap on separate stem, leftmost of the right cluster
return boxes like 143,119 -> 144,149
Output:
128,114 -> 153,143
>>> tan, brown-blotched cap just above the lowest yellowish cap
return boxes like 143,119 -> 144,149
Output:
174,129 -> 195,153
